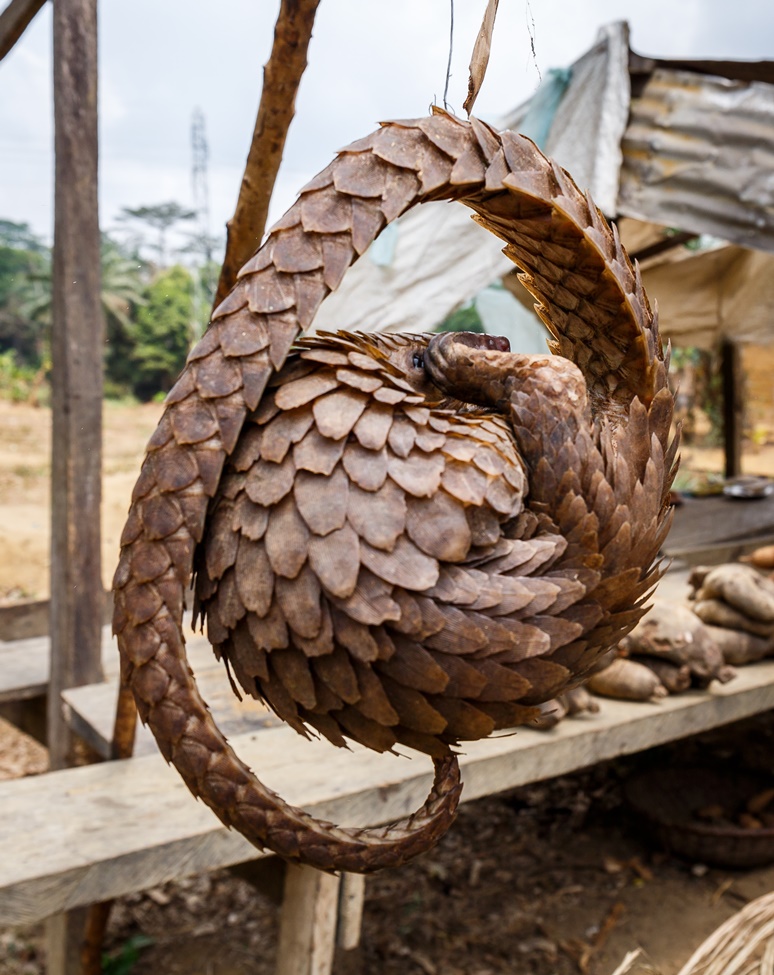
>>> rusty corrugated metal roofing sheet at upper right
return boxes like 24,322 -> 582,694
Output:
618,68 -> 774,251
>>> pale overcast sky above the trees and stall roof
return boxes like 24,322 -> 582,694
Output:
0,0 -> 774,252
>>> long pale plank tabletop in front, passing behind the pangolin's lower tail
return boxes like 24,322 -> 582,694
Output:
0,661 -> 774,924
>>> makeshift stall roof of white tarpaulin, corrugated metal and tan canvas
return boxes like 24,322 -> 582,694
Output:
315,23 -> 774,345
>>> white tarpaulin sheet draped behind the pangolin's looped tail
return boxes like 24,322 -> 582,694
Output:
315,23 -> 629,332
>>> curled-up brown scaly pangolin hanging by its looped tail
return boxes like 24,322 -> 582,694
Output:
114,111 -> 676,872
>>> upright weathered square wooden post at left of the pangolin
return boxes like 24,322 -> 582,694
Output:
47,0 -> 104,975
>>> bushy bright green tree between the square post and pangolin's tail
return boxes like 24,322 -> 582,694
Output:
131,265 -> 194,400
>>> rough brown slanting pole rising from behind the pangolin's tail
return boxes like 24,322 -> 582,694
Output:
215,0 -> 320,306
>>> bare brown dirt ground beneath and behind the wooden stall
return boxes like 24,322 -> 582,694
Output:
0,400 -> 774,975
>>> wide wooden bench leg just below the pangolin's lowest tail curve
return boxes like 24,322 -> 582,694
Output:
276,864 -> 341,975
